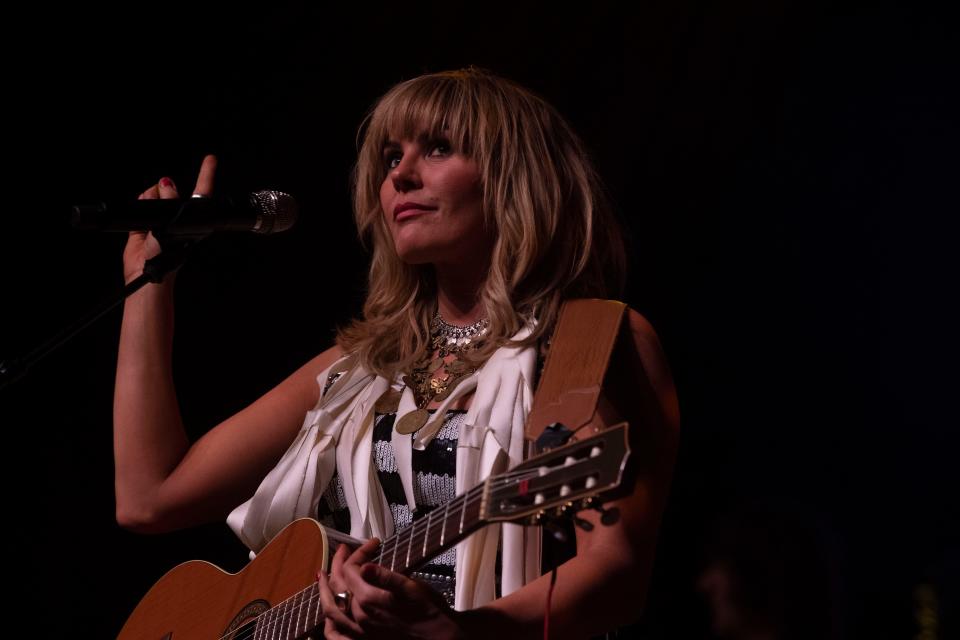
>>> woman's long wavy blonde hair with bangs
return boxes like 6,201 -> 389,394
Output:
337,67 -> 626,377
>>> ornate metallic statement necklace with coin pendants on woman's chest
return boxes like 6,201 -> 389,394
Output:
396,311 -> 490,434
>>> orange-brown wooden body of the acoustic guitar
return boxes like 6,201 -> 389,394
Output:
117,518 -> 329,640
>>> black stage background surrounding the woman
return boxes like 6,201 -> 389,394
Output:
0,0 -> 960,638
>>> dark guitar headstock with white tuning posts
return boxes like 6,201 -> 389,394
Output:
481,422 -> 630,524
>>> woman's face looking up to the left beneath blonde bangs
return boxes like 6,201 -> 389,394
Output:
380,134 -> 493,266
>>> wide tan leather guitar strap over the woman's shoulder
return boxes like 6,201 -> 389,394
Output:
525,298 -> 627,444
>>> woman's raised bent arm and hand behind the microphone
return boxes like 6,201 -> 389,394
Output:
113,156 -> 341,533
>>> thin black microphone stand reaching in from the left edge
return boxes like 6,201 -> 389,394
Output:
0,234 -> 209,389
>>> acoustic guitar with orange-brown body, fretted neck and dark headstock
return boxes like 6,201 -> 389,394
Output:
118,423 -> 630,640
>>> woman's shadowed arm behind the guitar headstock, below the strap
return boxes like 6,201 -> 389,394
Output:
462,309 -> 680,638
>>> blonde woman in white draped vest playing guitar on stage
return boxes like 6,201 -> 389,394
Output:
114,69 -> 678,638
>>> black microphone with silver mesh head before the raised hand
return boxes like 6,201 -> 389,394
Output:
72,191 -> 298,236
